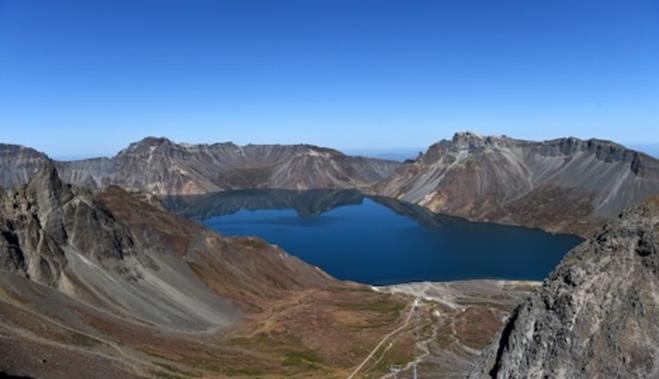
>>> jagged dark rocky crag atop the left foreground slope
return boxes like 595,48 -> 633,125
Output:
0,160 -> 133,287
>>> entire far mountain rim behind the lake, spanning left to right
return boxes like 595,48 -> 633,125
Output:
5,132 -> 659,236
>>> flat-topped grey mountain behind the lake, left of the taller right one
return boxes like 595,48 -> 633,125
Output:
111,138 -> 399,194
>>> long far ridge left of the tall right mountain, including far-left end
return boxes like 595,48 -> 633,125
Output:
0,137 -> 400,195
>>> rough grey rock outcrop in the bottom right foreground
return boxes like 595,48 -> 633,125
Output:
471,198 -> 659,378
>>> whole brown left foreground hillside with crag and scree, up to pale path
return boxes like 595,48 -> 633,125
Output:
0,164 -> 411,378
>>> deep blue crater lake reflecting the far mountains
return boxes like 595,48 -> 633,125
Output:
169,191 -> 581,285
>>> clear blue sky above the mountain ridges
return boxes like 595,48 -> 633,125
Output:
0,0 -> 659,156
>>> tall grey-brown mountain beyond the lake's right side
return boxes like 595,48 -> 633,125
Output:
370,132 -> 659,235
